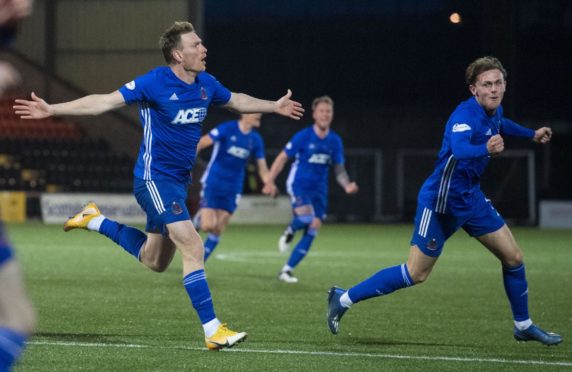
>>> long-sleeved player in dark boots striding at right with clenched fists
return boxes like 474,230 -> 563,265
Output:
327,57 -> 562,345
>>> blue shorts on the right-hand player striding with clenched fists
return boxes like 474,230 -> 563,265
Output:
411,194 -> 505,257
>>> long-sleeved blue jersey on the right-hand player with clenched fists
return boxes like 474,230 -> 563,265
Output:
418,97 -> 534,214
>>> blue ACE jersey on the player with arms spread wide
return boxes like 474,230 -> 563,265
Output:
119,66 -> 231,182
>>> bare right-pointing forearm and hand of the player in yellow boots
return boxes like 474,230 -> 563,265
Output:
224,89 -> 304,120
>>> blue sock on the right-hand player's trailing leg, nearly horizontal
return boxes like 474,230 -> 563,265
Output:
348,264 -> 415,303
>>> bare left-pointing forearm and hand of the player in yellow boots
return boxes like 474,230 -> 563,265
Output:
14,90 -> 125,119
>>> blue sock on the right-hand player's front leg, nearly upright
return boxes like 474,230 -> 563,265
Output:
502,264 -> 530,322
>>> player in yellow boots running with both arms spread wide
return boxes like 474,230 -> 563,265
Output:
14,22 -> 303,349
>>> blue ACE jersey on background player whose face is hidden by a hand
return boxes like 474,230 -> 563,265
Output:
201,120 -> 265,194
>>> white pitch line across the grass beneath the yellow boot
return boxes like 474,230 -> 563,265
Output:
28,341 -> 572,367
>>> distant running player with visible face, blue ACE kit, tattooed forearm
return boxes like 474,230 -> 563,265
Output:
263,96 -> 358,283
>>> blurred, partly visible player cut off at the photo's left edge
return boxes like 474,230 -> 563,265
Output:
0,0 -> 36,372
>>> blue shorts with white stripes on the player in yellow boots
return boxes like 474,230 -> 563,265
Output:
133,178 -> 191,235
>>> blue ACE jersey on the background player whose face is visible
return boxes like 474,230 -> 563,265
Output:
284,126 -> 344,194
